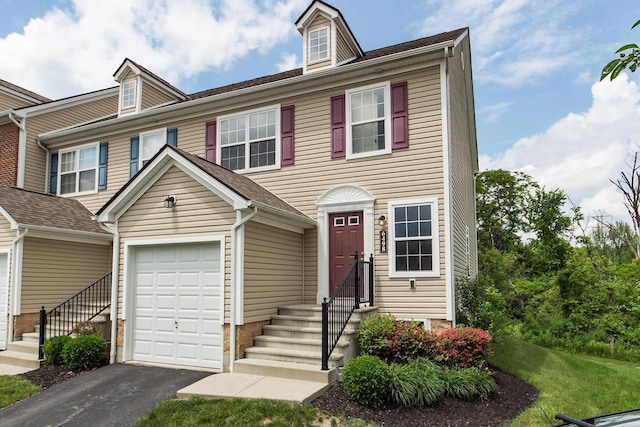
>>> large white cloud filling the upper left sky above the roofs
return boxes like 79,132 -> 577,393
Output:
0,0 -> 307,98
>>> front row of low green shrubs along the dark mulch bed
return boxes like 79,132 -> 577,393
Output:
342,356 -> 497,407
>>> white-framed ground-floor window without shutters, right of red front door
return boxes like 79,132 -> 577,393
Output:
389,198 -> 440,277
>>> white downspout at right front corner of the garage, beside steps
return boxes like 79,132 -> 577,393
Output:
230,206 -> 258,372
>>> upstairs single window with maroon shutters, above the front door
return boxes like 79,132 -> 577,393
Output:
346,82 -> 391,158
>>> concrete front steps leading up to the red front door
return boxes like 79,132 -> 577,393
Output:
233,305 -> 378,384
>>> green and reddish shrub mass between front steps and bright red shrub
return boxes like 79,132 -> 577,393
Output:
356,315 -> 436,363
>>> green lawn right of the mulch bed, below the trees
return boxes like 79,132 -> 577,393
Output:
491,337 -> 640,427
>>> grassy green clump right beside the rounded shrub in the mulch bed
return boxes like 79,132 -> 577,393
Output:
389,359 -> 445,406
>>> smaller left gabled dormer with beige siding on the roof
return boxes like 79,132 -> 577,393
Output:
113,58 -> 187,116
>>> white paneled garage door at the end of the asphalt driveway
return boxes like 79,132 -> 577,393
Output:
132,243 -> 223,369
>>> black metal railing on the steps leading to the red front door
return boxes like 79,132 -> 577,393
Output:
322,252 -> 373,371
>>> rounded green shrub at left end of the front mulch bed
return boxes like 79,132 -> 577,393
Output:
342,356 -> 389,408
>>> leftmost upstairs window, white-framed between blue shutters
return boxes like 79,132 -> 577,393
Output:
58,144 -> 98,195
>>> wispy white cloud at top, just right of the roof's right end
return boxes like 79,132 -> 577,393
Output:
418,0 -> 584,86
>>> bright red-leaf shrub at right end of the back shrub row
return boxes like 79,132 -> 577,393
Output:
435,328 -> 493,368
